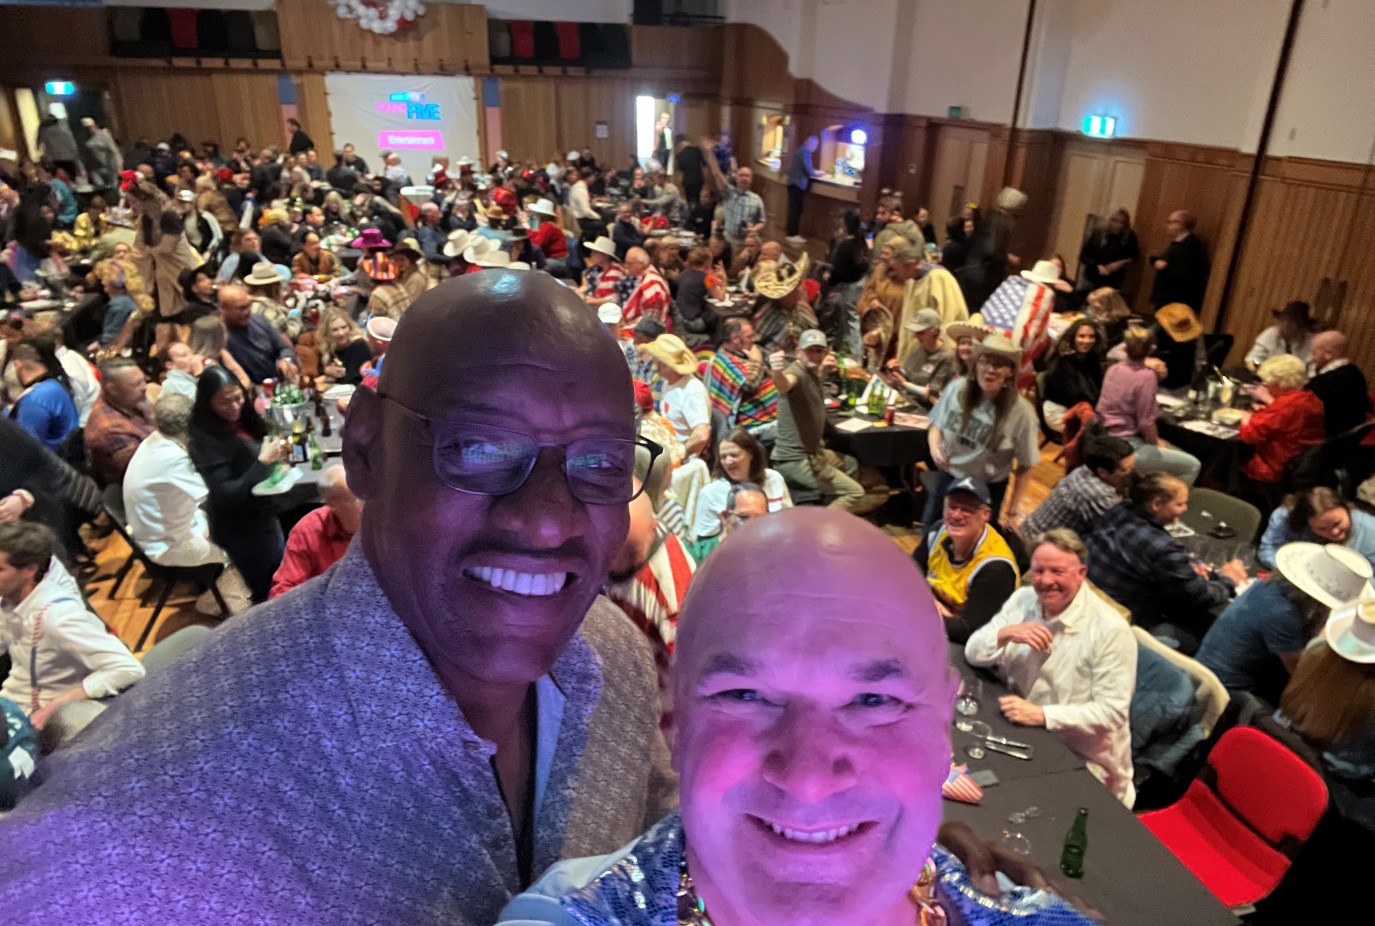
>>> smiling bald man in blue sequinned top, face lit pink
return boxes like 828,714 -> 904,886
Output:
498,510 -> 1088,926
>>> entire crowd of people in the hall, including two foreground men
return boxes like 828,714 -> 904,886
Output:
0,119 -> 1375,923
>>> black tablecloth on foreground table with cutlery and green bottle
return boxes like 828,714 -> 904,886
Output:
945,644 -> 1238,926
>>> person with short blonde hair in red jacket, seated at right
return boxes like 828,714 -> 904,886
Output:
1238,354 -> 1323,486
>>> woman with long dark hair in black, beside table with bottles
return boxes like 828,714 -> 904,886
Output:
187,366 -> 285,603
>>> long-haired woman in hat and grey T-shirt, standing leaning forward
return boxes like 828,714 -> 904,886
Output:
921,334 -> 1041,527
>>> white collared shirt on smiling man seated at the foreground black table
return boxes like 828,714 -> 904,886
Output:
964,582 -> 1137,806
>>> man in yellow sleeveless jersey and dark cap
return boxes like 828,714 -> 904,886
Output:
913,477 -> 1020,643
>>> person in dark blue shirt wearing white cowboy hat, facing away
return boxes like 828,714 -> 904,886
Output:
1195,542 -> 1371,704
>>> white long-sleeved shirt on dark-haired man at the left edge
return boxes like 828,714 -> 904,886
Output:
0,557 -> 144,714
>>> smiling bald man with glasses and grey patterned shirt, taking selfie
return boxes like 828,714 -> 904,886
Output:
0,271 -> 674,926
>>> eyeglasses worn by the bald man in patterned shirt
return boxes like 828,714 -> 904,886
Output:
380,396 -> 664,505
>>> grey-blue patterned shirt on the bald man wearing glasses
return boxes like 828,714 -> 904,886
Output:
0,543 -> 677,926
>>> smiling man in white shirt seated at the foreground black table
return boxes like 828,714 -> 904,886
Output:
964,528 -> 1136,806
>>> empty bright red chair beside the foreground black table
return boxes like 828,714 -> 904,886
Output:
1139,726 -> 1327,912
